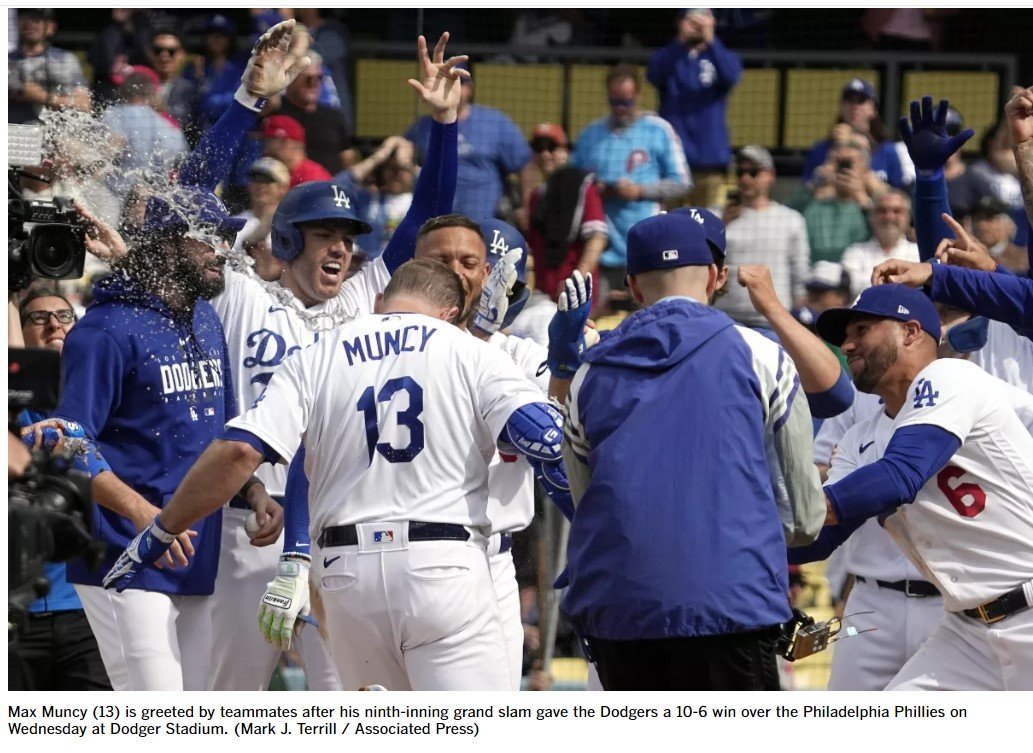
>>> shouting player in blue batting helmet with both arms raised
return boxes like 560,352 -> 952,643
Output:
175,29 -> 466,690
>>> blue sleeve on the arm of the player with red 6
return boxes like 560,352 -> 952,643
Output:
825,423 -> 962,521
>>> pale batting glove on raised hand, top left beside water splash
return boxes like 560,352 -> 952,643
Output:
236,19 -> 312,109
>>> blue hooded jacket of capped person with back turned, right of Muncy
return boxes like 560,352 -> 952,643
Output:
562,299 -> 796,640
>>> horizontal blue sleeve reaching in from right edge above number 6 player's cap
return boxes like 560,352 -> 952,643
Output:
930,264 -> 1033,338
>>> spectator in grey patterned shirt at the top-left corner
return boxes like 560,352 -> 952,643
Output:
7,8 -> 90,123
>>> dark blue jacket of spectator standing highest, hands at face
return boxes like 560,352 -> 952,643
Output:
646,37 -> 743,169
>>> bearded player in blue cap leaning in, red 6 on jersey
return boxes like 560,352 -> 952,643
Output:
797,285 -> 1033,690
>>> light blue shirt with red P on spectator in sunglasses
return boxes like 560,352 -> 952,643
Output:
570,114 -> 689,268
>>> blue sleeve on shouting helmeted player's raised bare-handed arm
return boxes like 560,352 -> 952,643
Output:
381,116 -> 459,273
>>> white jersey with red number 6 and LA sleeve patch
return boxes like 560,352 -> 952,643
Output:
863,358 -> 1033,611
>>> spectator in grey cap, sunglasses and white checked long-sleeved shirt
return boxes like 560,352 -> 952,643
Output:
714,147 -> 811,328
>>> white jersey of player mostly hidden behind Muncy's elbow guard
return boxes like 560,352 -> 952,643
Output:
488,333 -> 549,533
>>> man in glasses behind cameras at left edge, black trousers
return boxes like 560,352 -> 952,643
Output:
8,287 -> 112,690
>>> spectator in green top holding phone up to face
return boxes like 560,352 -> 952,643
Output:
789,136 -> 885,263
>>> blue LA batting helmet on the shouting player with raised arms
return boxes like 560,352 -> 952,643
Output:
272,181 -> 373,261
